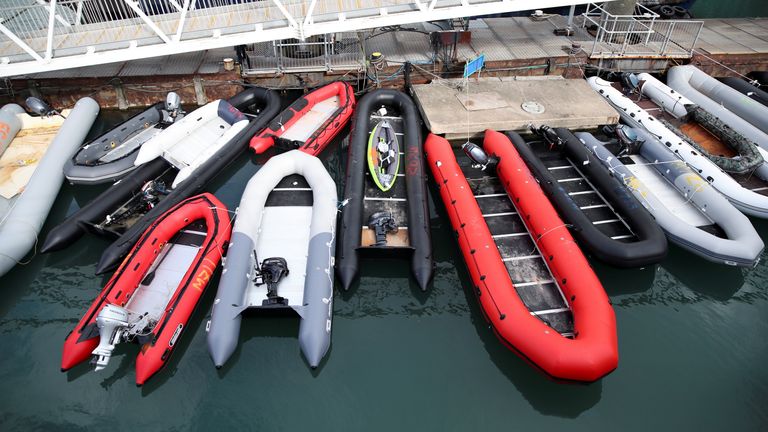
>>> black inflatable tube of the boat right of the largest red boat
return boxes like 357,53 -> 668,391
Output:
507,128 -> 667,268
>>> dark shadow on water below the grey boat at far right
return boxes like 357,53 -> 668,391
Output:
661,245 -> 744,301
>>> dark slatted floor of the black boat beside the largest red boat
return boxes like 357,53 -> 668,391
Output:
531,143 -> 637,243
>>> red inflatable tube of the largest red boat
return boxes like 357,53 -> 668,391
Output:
425,130 -> 618,382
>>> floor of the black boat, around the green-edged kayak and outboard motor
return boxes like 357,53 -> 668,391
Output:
360,114 -> 411,248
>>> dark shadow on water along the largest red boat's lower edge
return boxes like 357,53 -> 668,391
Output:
456,261 -> 603,418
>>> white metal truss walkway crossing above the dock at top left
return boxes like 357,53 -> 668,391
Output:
0,0 -> 586,77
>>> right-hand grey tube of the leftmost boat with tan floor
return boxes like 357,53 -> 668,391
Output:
0,98 -> 99,276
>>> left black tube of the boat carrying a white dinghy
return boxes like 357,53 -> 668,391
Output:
40,158 -> 171,253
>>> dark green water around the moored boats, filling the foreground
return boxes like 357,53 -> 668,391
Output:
0,102 -> 768,431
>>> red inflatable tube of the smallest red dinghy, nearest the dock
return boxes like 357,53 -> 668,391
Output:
251,81 -> 355,156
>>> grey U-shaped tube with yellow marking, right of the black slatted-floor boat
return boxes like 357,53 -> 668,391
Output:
576,128 -> 764,267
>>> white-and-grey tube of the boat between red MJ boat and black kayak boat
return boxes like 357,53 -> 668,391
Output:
207,150 -> 338,368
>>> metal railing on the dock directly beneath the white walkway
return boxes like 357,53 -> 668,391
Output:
244,32 -> 365,74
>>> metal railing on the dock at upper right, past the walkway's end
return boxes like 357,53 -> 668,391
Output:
582,3 -> 704,58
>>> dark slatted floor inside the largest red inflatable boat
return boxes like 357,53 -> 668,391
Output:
455,150 -> 573,337
